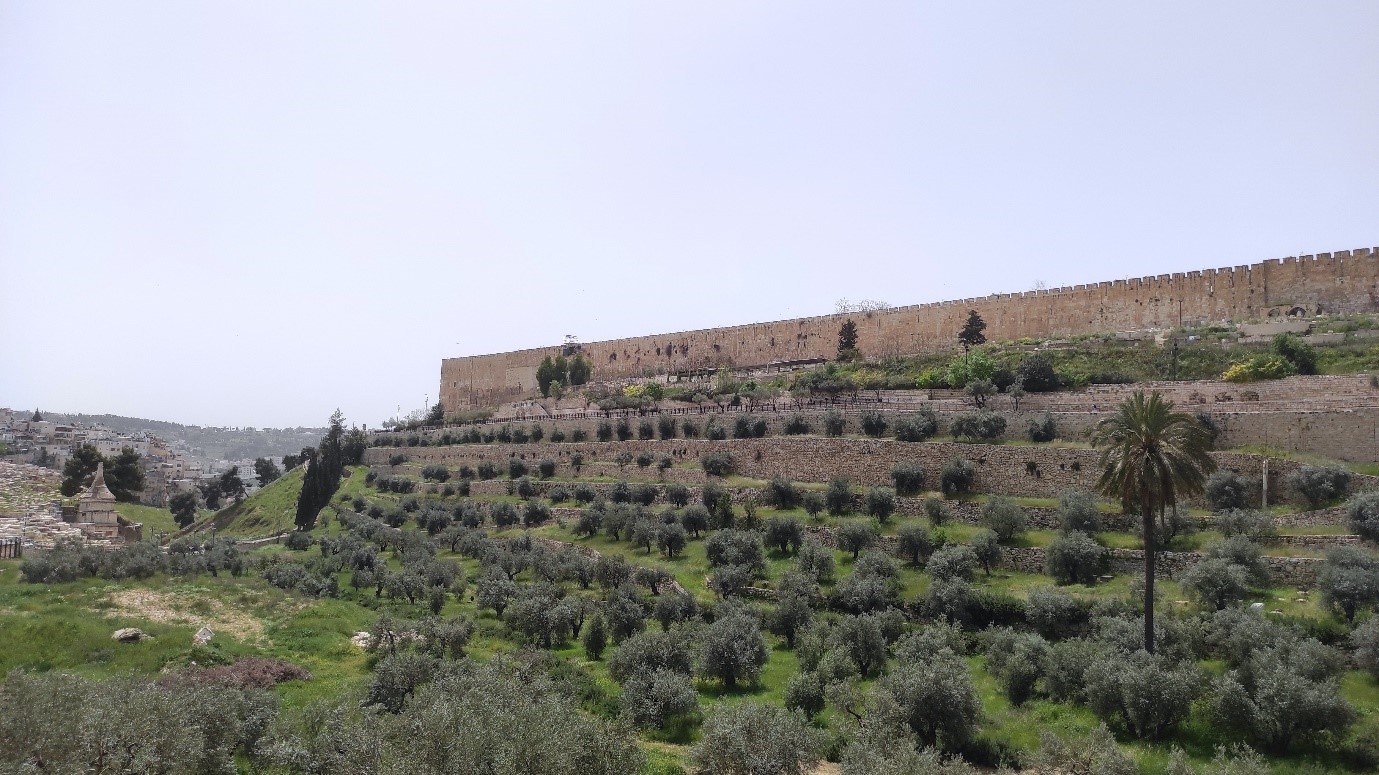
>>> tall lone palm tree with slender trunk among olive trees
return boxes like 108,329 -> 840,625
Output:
1092,392 -> 1216,654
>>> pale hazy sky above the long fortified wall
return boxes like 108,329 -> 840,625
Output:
0,0 -> 1379,426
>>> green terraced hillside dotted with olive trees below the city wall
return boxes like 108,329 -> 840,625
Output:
8,386 -> 1379,775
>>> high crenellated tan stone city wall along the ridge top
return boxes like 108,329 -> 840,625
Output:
440,248 -> 1379,410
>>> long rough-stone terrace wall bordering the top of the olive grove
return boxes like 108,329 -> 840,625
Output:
364,436 -> 1379,502
